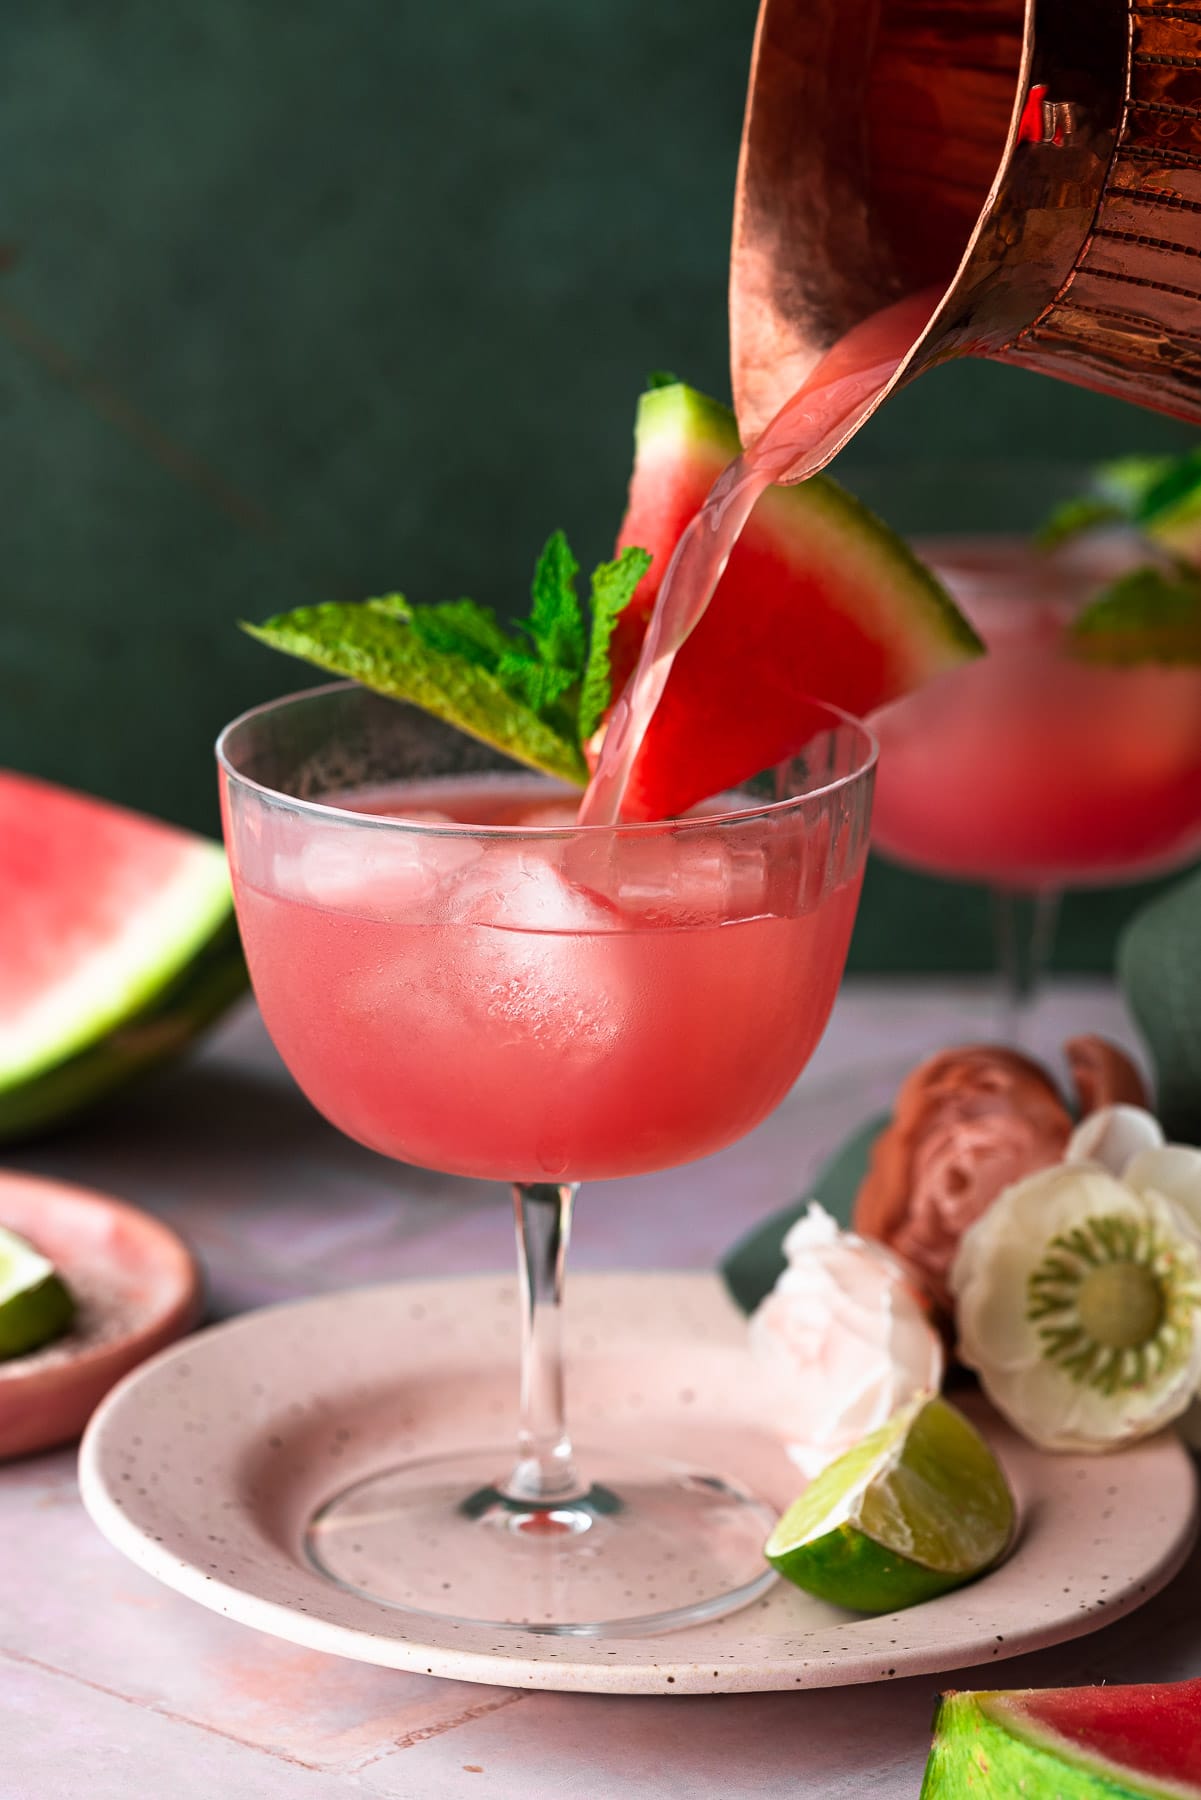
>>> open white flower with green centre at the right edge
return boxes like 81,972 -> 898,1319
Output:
951,1107 -> 1201,1451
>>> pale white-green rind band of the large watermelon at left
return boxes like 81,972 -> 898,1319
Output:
0,839 -> 232,1098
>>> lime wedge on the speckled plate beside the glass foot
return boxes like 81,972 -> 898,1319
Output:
765,1399 -> 1016,1613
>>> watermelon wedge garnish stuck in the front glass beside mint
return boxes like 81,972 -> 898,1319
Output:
610,383 -> 983,819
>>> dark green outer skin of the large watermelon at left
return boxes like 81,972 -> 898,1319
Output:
0,911 -> 250,1143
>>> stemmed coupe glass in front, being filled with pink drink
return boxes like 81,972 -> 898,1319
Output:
218,684 -> 875,1634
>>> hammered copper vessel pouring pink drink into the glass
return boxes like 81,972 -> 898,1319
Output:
731,0 -> 1201,441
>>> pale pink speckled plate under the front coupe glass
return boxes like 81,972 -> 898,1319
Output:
81,1274 -> 1196,1694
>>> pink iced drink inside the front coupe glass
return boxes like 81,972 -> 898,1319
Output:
234,776 -> 859,1181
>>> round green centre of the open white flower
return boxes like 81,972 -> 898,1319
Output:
1026,1213 -> 1201,1393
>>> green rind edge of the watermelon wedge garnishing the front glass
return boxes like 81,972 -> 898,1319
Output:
636,383 -> 983,677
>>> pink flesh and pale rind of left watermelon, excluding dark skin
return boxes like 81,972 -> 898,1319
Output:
0,772 -> 230,1098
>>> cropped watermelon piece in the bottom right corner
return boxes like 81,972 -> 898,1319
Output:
922,1681 -> 1201,1800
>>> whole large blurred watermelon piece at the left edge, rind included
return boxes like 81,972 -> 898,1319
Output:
0,770 -> 245,1139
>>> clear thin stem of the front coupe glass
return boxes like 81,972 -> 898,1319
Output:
504,1181 -> 583,1505
